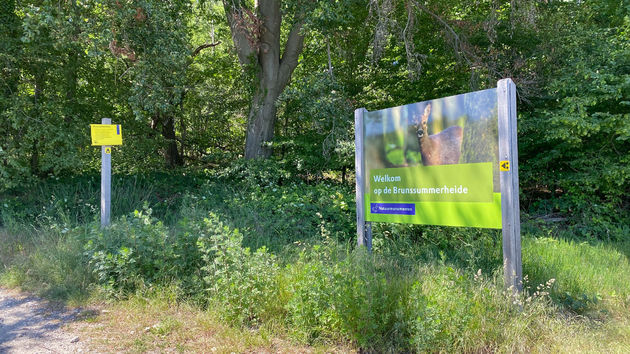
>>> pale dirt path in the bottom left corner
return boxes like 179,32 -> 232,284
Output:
0,288 -> 91,353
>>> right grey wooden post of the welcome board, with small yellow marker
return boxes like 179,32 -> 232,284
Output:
497,79 -> 523,293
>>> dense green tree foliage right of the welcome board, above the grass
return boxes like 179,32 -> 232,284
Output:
519,2 -> 630,239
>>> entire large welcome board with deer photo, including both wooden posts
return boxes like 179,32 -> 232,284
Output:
354,79 -> 523,293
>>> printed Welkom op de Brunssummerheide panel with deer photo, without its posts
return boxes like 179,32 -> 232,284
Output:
363,89 -> 501,229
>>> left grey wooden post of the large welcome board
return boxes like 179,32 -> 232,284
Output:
354,108 -> 372,251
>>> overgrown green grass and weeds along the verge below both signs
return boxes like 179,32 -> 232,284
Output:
0,170 -> 630,352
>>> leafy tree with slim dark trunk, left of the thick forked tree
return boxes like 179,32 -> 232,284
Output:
108,0 -> 225,168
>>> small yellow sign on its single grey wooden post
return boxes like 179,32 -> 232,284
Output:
90,118 -> 122,228
